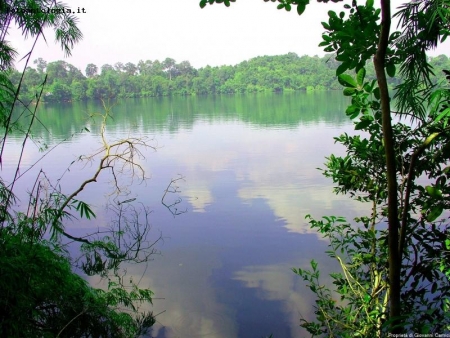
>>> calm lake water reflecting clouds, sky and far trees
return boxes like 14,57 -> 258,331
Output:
3,92 -> 363,338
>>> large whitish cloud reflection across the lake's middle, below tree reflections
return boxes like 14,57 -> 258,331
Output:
162,123 -> 365,233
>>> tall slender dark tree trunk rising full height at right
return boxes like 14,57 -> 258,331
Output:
373,0 -> 401,333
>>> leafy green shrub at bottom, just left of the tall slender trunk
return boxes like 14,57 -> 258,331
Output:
293,215 -> 388,337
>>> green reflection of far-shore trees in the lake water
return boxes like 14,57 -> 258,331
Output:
23,91 -> 347,143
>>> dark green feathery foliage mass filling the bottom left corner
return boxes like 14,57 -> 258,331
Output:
0,228 -> 154,337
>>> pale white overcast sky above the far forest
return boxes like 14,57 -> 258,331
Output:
8,0 -> 450,72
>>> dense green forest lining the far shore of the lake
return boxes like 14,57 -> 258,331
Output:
12,53 -> 450,102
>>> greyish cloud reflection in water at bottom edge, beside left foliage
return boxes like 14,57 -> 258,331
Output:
127,247 -> 237,338
